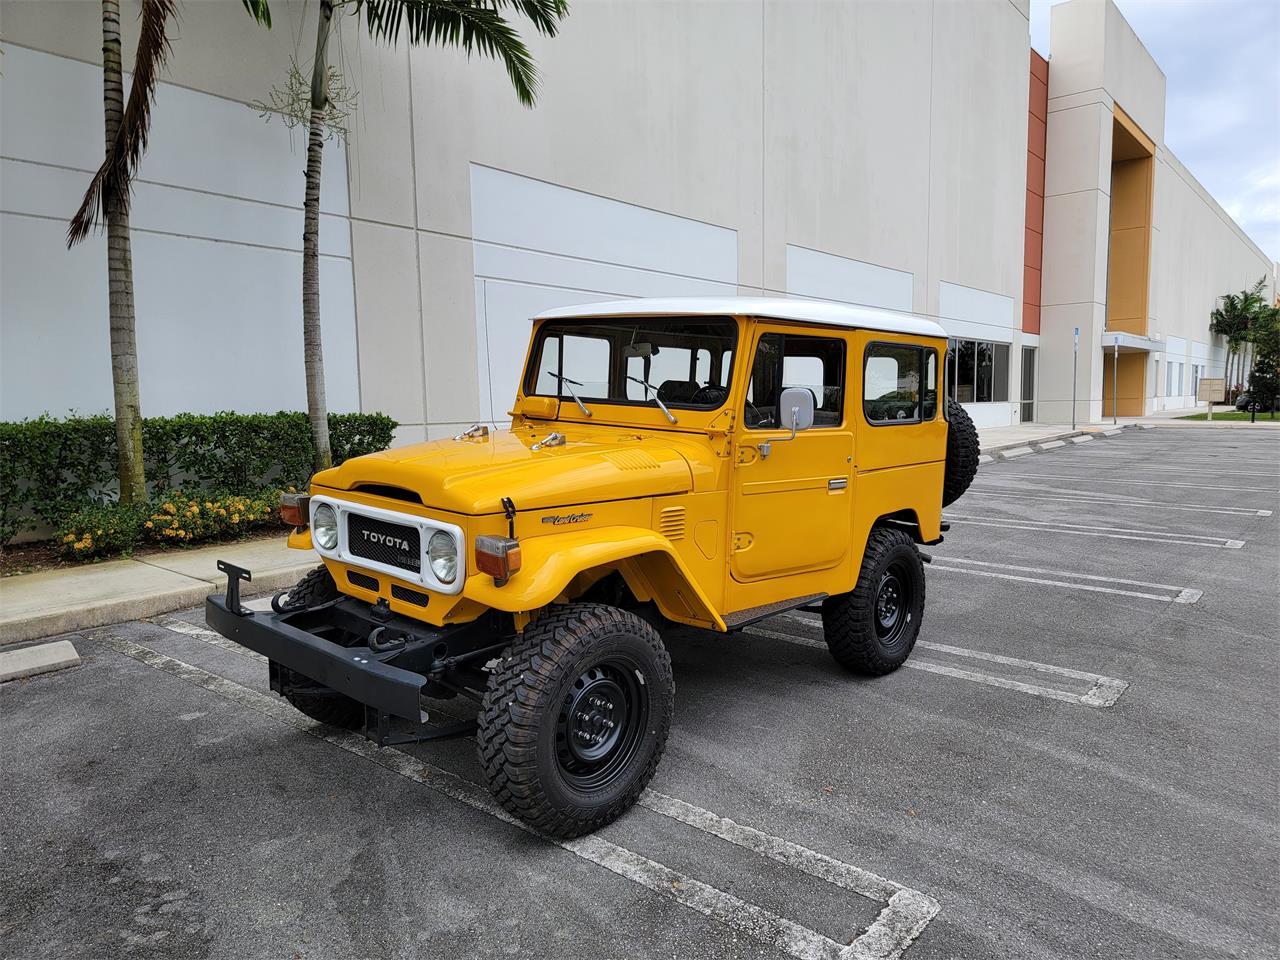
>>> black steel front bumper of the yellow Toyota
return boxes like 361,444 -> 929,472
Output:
205,594 -> 438,723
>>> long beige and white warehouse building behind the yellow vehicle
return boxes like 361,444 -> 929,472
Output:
0,0 -> 1275,440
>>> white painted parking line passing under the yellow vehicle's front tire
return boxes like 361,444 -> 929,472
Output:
91,632 -> 940,960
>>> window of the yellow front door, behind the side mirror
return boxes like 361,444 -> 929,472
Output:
742,333 -> 845,430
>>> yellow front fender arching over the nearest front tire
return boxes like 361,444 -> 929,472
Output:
462,526 -> 724,630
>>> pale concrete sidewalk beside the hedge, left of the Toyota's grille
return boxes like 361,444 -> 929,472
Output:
0,536 -> 320,646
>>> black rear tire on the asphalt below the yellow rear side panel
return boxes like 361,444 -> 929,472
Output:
822,526 -> 924,677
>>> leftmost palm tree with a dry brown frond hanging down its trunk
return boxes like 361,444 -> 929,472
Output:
67,0 -> 177,503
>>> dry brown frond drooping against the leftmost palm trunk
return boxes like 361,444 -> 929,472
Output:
67,0 -> 178,247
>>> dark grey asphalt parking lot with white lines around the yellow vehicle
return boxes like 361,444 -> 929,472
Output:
0,428 -> 1280,960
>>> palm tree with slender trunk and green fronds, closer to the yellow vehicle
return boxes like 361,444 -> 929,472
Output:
242,0 -> 568,470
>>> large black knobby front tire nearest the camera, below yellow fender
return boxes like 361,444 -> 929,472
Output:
476,603 -> 676,838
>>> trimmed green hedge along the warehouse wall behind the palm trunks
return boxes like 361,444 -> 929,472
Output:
0,411 -> 397,544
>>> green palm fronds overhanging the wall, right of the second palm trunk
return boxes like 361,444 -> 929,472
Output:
361,0 -> 568,106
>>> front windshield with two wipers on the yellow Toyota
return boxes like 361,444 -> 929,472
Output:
525,316 -> 737,412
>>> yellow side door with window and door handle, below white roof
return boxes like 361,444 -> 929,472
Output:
730,326 -> 854,582
